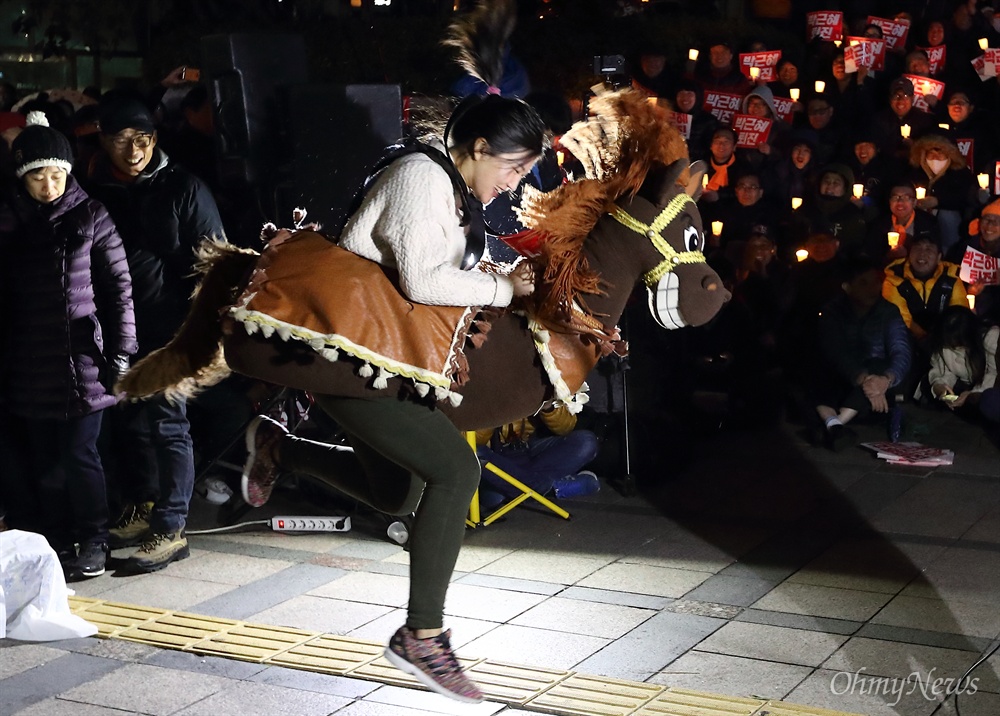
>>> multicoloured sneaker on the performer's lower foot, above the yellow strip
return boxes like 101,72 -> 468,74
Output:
385,626 -> 483,704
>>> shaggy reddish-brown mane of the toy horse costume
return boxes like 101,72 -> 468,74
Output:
519,89 -> 688,321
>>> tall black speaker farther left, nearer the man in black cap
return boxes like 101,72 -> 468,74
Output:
200,33 -> 308,185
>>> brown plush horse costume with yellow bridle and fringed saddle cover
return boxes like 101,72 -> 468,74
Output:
120,92 -> 729,430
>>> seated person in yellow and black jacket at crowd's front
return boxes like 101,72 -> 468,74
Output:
882,235 -> 968,397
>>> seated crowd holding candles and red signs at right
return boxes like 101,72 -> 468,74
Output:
631,2 -> 1000,449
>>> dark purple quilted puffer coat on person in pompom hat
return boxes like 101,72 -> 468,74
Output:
0,175 -> 136,420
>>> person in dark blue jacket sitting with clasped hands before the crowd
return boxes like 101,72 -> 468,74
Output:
811,256 -> 912,450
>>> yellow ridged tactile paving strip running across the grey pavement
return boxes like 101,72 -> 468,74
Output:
69,597 -> 858,716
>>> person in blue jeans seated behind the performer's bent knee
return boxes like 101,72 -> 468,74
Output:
476,406 -> 600,510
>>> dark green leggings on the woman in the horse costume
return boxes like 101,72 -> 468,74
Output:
279,395 -> 480,629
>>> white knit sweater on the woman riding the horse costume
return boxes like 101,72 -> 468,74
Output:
340,154 -> 513,306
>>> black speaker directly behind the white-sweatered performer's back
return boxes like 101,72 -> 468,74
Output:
287,85 -> 403,231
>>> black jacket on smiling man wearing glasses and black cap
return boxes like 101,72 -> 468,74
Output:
88,149 -> 225,356
